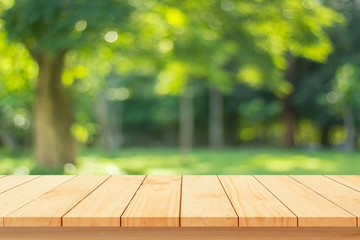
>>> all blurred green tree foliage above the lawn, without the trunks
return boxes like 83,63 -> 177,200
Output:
0,0 -> 360,150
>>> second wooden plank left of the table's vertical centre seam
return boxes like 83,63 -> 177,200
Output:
63,176 -> 145,227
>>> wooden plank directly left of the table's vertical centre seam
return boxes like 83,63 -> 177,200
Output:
121,175 -> 181,227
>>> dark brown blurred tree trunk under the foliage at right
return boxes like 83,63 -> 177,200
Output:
282,96 -> 295,147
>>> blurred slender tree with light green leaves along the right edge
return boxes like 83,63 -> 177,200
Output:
327,0 -> 360,151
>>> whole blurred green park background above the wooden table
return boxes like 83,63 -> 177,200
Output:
0,0 -> 360,174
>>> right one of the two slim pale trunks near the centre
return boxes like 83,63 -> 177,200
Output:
209,87 -> 223,150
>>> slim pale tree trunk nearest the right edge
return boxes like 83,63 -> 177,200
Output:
343,107 -> 356,152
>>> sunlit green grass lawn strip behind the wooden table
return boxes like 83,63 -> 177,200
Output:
0,148 -> 360,174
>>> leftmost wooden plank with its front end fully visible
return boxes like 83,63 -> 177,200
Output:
4,175 -> 109,227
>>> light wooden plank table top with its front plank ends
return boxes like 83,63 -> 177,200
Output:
0,175 -> 360,227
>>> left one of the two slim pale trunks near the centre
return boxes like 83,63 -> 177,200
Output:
179,84 -> 194,153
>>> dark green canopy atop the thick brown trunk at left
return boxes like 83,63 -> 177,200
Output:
2,0 -> 132,53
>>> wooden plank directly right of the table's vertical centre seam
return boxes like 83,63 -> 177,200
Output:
181,175 -> 238,227
